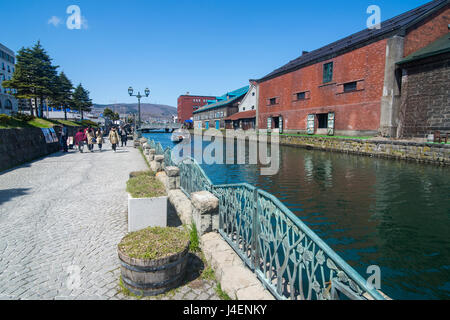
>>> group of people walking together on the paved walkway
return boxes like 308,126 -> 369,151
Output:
74,127 -> 128,152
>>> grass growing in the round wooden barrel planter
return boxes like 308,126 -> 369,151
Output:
119,227 -> 189,260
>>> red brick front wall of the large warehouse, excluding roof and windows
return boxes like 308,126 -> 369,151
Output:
258,40 -> 386,133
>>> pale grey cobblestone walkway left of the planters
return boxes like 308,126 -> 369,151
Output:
0,143 -> 216,299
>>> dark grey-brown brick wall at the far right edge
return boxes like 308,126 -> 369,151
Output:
402,54 -> 450,137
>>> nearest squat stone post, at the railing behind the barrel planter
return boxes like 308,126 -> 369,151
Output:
191,191 -> 219,237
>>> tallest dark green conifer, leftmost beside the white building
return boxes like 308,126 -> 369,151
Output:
2,41 -> 58,117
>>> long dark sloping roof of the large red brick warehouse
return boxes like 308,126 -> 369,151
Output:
257,0 -> 450,82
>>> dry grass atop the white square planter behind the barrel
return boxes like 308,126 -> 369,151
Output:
127,171 -> 167,198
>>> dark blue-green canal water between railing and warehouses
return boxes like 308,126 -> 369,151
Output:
144,133 -> 450,299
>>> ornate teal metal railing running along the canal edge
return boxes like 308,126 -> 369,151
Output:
143,138 -> 384,300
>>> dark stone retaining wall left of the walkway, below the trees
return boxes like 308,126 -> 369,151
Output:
0,128 -> 60,172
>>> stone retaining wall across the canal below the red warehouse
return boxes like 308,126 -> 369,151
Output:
280,135 -> 450,166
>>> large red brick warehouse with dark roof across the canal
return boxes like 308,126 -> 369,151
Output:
257,0 -> 450,137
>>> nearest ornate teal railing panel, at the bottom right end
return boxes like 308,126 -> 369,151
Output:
255,190 -> 383,300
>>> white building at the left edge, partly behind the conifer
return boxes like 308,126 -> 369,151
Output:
0,43 -> 18,114
